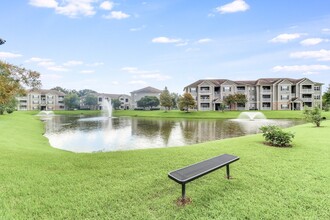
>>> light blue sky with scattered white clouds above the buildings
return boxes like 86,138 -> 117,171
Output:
0,0 -> 330,94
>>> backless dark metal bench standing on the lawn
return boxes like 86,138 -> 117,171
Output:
168,154 -> 239,200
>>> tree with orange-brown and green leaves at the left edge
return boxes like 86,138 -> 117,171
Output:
0,61 -> 41,108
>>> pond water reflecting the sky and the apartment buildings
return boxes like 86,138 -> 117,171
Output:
41,116 -> 303,153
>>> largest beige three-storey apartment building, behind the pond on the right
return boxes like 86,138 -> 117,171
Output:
184,78 -> 323,111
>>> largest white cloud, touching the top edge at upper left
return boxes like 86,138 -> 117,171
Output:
29,0 -> 96,18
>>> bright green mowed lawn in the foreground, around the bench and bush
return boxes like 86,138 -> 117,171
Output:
0,112 -> 330,219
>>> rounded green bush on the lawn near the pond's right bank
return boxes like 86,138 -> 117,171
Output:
260,125 -> 294,147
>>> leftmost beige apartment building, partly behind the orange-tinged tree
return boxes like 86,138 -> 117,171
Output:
17,89 -> 65,111
